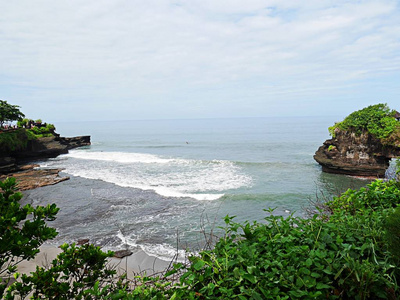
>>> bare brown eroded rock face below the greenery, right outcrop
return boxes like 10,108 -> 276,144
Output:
314,130 -> 400,178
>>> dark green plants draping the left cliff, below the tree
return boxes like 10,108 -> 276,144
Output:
0,128 -> 36,153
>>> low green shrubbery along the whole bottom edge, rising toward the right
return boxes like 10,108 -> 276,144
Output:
0,180 -> 400,299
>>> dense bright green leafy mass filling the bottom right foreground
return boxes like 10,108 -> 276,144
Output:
170,181 -> 400,299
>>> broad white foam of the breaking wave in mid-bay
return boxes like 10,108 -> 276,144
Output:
47,150 -> 252,200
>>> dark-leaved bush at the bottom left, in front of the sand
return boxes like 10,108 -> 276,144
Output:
5,244 -> 116,299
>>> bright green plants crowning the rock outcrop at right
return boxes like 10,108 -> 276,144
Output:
329,103 -> 400,146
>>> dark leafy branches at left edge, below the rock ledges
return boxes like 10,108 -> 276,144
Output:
0,178 -> 58,295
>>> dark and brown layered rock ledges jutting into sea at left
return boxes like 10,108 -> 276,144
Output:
0,135 -> 91,191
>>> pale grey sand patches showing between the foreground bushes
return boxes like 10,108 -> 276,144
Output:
18,245 -> 170,279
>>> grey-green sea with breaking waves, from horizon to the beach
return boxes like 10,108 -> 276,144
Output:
23,117 -> 367,259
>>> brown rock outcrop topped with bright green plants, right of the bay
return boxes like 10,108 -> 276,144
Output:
314,104 -> 400,177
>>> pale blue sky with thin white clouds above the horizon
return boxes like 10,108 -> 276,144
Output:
0,0 -> 400,122
